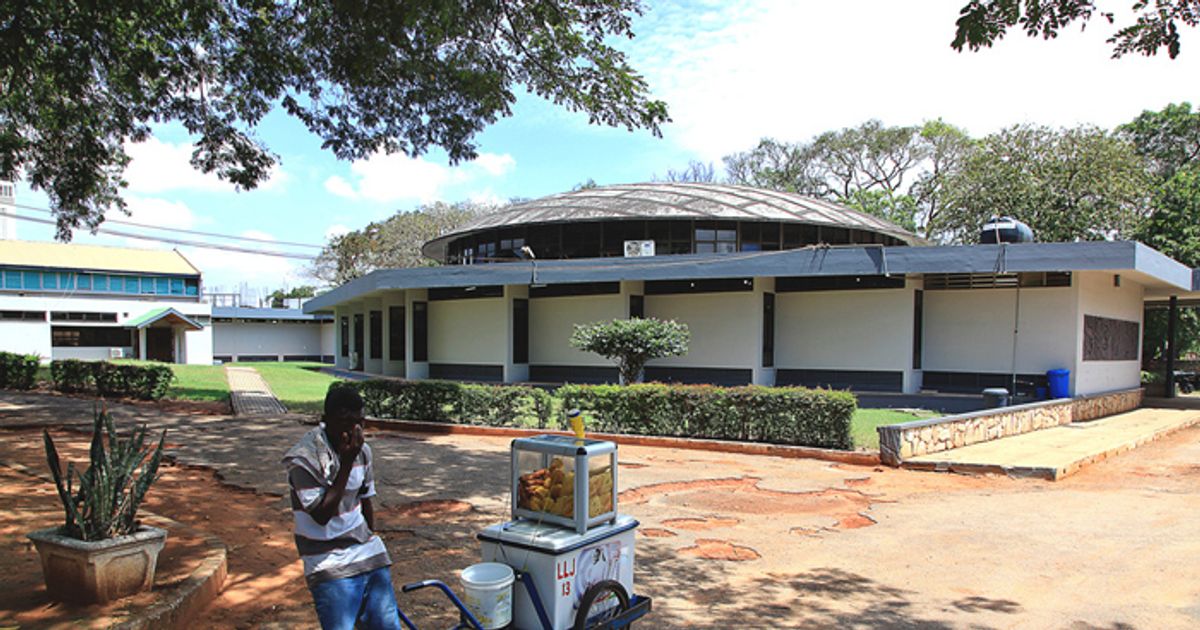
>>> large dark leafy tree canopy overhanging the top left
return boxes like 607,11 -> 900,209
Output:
0,0 -> 668,240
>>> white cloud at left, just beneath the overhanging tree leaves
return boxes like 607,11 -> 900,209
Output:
125,137 -> 288,194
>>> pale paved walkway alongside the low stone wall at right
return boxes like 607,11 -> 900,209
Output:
904,406 -> 1200,481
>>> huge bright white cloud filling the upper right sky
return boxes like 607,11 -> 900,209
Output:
629,0 -> 1200,160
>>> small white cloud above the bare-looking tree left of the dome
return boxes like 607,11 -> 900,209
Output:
325,154 -> 516,203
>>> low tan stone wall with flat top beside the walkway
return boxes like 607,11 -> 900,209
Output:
878,388 -> 1144,466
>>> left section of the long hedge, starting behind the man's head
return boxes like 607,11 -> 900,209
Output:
343,379 -> 553,428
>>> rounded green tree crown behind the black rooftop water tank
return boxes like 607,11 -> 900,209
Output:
940,125 -> 1150,242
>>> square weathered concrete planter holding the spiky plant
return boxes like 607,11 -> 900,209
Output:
29,526 -> 167,604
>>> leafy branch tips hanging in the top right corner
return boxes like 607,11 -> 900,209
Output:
950,0 -> 1200,59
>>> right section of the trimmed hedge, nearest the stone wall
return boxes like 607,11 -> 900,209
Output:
556,383 -> 857,449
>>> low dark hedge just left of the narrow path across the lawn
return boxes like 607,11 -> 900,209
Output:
50,359 -> 175,401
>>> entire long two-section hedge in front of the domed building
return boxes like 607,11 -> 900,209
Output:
331,379 -> 857,450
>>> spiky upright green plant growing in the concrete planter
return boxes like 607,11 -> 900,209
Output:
42,409 -> 167,540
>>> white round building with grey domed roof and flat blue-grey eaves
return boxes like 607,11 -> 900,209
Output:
305,182 -> 1194,396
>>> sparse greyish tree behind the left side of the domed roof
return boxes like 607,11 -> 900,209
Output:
310,202 -> 496,284
